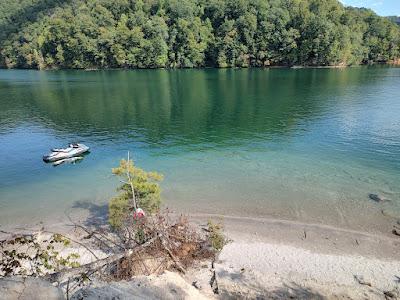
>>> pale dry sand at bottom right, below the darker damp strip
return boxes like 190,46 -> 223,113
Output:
215,242 -> 400,299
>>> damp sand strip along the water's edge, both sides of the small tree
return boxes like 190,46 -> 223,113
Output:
0,211 -> 400,261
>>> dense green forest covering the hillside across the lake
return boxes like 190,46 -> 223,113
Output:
0,0 -> 400,69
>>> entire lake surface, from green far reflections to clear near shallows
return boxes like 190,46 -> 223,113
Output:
0,67 -> 400,231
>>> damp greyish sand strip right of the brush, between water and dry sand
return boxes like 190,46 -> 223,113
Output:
189,214 -> 400,261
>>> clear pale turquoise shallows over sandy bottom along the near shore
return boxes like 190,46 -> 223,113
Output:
0,145 -> 400,231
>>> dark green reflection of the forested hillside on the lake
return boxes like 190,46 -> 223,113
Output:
1,70 -> 368,144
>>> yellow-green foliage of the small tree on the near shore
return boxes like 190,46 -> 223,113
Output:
109,159 -> 163,228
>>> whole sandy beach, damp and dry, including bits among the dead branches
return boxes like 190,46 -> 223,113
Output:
1,214 -> 400,299
